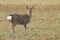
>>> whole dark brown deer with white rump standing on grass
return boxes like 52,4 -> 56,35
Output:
7,5 -> 34,33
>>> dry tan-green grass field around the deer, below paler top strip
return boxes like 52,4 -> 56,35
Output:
0,4 -> 60,40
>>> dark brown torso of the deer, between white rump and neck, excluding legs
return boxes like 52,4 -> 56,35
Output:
12,14 -> 30,24
